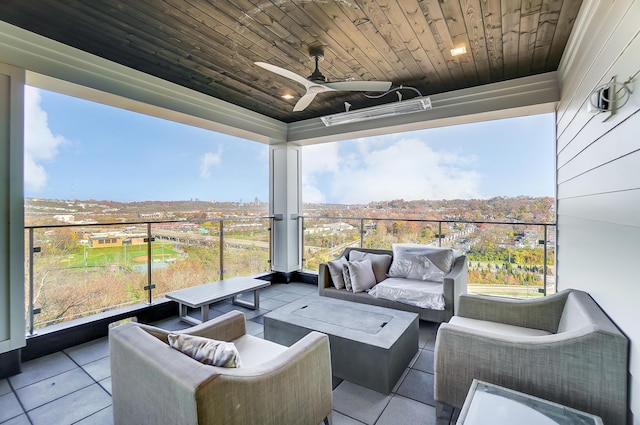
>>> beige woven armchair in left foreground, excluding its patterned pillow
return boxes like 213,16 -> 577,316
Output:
109,311 -> 332,425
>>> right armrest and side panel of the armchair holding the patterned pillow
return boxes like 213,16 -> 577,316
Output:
198,332 -> 332,425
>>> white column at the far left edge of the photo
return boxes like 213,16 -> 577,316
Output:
0,63 -> 26,358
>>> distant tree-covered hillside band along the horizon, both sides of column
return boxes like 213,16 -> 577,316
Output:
25,196 -> 555,225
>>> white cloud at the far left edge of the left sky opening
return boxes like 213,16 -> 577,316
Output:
24,87 -> 69,192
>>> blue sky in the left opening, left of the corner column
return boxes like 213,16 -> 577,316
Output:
25,88 -> 269,202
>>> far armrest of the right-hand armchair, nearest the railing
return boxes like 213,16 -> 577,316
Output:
456,291 -> 570,333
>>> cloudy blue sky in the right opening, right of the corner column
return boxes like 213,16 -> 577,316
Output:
303,114 -> 555,203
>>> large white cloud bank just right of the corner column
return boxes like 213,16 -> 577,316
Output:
303,137 -> 481,203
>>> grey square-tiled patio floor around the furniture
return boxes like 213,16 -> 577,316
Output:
0,283 -> 456,425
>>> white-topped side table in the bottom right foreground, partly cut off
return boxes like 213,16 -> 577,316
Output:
457,379 -> 602,425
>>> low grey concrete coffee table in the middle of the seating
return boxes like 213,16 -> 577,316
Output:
264,297 -> 418,394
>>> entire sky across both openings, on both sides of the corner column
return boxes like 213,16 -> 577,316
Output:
25,87 -> 555,203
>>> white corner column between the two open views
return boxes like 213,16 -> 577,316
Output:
269,143 -> 302,273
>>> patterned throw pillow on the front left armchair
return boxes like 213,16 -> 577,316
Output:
168,334 -> 242,367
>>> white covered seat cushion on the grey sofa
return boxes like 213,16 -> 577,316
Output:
369,277 -> 445,310
